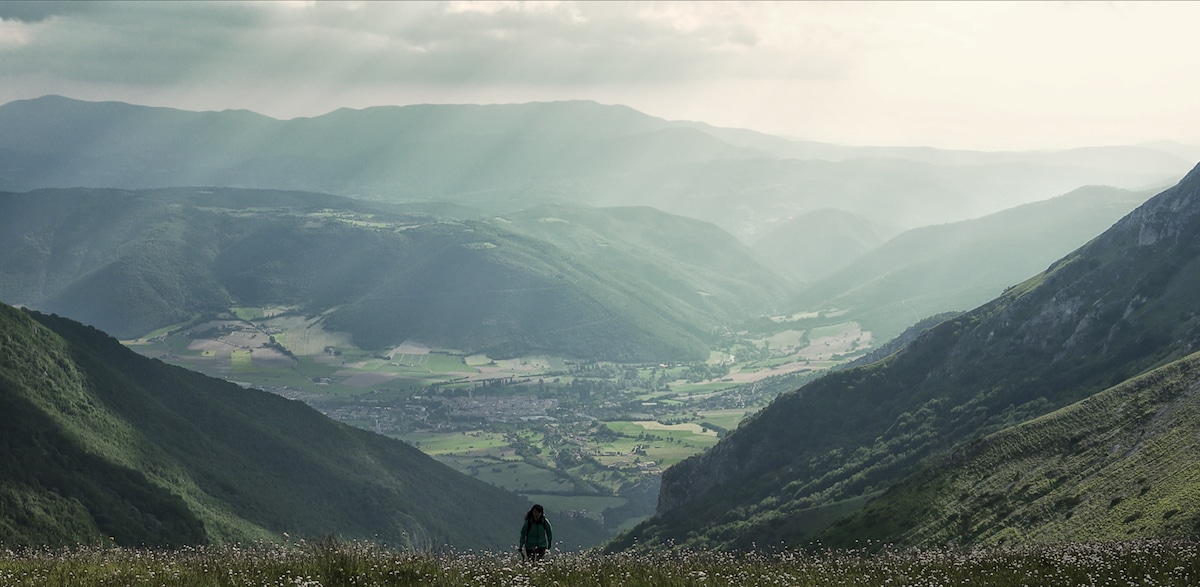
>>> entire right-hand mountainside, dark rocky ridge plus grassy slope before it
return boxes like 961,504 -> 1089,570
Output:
616,160 -> 1200,547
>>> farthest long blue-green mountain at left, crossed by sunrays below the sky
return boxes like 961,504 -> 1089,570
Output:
0,96 -> 758,206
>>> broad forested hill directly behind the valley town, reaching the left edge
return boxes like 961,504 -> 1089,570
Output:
0,188 -> 786,360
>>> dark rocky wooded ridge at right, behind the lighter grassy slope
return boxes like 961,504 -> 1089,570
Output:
616,162 -> 1200,547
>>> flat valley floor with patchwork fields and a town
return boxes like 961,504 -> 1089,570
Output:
125,307 -> 871,532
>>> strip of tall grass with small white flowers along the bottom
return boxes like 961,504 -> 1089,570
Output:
0,540 -> 1200,587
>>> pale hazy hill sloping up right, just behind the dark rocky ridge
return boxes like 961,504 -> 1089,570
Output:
790,186 -> 1153,340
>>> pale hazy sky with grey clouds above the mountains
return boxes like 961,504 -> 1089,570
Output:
0,1 -> 1200,149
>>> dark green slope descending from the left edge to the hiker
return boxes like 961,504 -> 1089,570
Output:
0,306 -> 601,549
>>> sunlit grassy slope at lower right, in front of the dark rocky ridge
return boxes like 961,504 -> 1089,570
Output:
820,354 -> 1200,547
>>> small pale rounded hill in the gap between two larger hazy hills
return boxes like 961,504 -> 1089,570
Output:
752,210 -> 901,283
